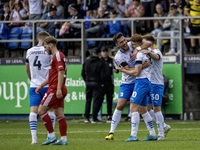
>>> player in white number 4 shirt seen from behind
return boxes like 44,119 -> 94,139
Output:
26,31 -> 56,144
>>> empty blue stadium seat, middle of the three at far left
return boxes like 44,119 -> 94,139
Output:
8,27 -> 22,49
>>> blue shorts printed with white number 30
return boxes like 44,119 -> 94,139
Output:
148,84 -> 164,106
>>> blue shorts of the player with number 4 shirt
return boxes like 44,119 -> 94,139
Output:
29,87 -> 48,107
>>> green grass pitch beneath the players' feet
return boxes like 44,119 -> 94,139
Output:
0,119 -> 200,150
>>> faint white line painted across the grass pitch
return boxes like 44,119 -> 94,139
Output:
0,128 -> 200,135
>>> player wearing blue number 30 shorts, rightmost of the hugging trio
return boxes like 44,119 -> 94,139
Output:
141,35 -> 171,140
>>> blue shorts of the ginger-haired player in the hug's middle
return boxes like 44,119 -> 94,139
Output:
130,78 -> 151,106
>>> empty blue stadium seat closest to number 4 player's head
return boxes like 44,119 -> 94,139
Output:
20,27 -> 33,49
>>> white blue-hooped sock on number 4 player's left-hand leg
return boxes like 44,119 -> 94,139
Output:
29,112 -> 37,139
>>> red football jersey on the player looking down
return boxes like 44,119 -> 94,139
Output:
48,51 -> 67,89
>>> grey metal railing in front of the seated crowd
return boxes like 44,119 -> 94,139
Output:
0,16 -> 200,64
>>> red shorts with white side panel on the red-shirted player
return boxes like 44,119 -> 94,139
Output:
41,87 -> 67,109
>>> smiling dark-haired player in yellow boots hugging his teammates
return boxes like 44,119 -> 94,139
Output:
105,33 -> 150,140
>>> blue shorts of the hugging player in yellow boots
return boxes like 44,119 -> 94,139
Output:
118,83 -> 135,101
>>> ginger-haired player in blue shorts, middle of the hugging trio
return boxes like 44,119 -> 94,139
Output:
118,34 -> 157,142
